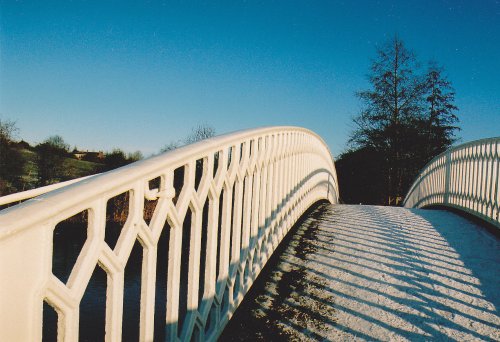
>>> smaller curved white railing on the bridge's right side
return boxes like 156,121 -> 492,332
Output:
404,137 -> 500,228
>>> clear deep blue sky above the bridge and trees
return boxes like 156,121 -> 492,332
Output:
0,0 -> 500,155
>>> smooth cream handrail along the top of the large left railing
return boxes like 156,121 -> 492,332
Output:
0,126 -> 338,239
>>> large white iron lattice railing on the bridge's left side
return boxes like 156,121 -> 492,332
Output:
0,127 -> 338,341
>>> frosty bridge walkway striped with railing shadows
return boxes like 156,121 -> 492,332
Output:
221,204 -> 500,341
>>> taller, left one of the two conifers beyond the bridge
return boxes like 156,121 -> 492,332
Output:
350,37 -> 425,202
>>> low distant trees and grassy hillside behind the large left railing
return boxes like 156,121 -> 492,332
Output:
0,119 -> 215,196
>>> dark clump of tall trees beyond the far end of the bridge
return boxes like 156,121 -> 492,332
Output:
335,37 -> 459,205
